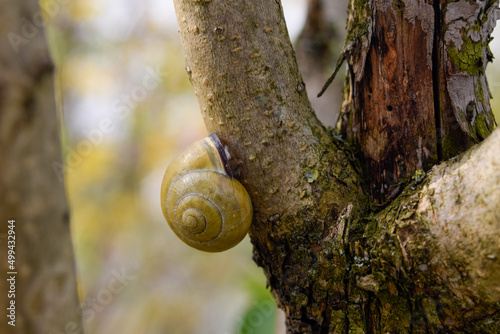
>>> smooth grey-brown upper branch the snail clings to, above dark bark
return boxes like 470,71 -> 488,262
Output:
175,0 -> 366,227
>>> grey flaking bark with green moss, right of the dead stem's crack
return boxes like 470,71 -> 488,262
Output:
440,0 -> 500,145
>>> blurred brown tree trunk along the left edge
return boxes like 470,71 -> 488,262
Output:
0,0 -> 83,334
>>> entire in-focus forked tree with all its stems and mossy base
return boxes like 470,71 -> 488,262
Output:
175,0 -> 500,333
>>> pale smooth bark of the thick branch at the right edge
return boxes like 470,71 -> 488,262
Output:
417,125 -> 500,303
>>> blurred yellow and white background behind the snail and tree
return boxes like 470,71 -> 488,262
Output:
41,0 -> 500,334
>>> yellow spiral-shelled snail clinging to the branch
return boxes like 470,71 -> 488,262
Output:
161,134 -> 253,252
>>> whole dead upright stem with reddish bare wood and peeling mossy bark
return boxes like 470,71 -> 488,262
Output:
343,0 -> 498,203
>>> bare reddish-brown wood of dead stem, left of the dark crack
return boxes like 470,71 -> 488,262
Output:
343,0 -> 438,203
